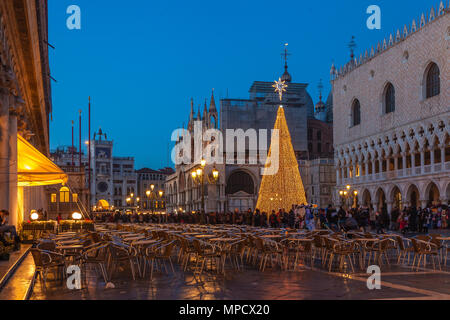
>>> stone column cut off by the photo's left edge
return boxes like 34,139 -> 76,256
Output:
0,88 -> 10,210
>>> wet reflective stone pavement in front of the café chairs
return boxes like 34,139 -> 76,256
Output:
32,258 -> 450,300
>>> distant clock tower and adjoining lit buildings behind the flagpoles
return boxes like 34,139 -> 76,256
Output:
47,129 -> 173,215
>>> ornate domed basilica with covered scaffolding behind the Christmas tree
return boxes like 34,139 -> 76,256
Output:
166,60 -> 335,212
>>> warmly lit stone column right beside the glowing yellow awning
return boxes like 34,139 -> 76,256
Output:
9,109 -> 17,228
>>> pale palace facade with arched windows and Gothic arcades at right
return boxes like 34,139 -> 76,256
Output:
331,2 -> 450,212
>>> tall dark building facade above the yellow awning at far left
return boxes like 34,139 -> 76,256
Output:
0,0 -> 52,224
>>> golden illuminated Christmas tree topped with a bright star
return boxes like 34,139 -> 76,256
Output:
256,79 -> 307,214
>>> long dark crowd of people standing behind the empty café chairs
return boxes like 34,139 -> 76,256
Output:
96,205 -> 450,234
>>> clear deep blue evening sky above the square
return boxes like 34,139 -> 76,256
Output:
49,0 -> 439,169
